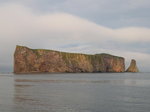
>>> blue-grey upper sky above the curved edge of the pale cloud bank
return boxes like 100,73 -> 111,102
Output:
0,0 -> 150,28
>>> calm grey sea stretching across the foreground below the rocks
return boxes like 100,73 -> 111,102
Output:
0,73 -> 150,112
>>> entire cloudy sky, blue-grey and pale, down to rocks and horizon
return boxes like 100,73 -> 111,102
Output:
0,0 -> 150,72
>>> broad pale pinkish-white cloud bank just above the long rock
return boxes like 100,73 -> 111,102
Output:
0,4 -> 150,70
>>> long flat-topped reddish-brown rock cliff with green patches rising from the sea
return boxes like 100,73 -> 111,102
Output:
14,46 -> 125,73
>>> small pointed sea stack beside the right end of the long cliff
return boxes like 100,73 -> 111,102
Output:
126,59 -> 139,72
